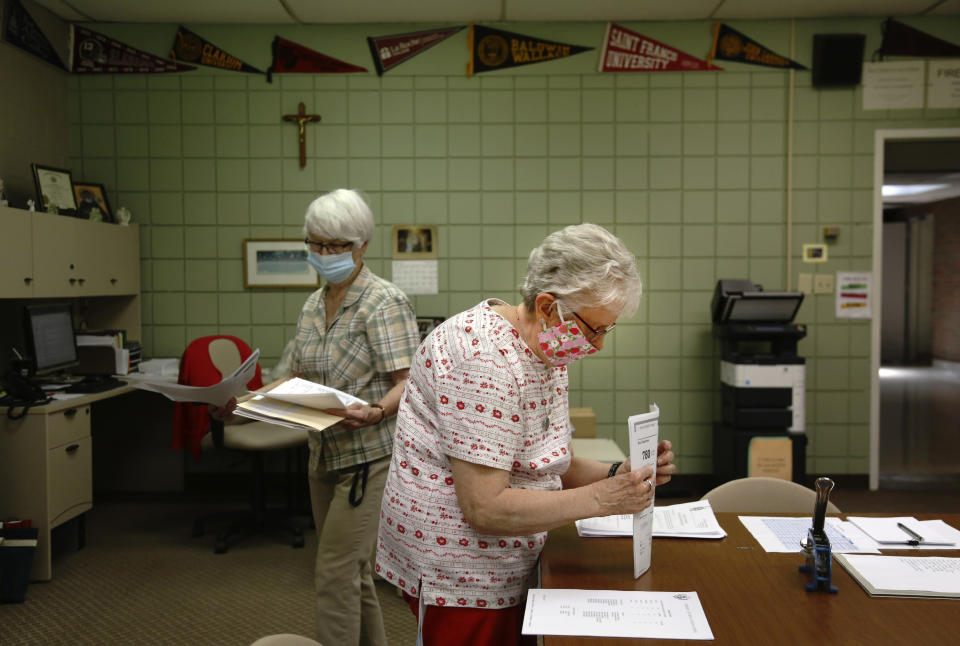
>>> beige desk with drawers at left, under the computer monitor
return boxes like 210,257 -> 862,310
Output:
0,386 -> 134,581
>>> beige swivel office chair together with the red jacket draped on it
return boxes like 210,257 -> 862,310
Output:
175,336 -> 307,554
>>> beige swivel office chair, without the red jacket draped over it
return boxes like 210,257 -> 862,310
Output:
187,337 -> 307,554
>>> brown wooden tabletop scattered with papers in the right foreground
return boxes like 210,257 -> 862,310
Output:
540,513 -> 960,646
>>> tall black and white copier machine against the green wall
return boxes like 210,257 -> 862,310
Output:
711,279 -> 807,482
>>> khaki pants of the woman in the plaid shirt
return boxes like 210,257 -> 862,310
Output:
309,456 -> 390,646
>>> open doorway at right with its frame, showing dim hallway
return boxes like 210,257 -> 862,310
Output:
870,129 -> 960,489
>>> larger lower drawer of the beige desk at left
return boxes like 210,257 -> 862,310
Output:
47,436 -> 93,529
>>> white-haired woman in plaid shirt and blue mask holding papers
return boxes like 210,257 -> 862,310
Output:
291,189 -> 420,646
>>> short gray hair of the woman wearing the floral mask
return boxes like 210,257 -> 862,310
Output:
520,223 -> 643,316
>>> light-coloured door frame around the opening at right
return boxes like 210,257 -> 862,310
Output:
870,128 -> 960,491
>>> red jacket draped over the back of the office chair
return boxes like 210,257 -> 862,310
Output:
172,335 -> 263,460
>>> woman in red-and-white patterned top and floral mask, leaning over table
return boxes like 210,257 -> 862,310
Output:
376,224 -> 675,646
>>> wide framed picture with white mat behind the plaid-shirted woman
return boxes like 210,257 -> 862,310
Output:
243,239 -> 320,288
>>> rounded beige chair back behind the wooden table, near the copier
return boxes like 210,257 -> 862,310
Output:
700,477 -> 841,514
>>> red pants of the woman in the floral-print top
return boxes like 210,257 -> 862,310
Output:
403,592 -> 537,646
